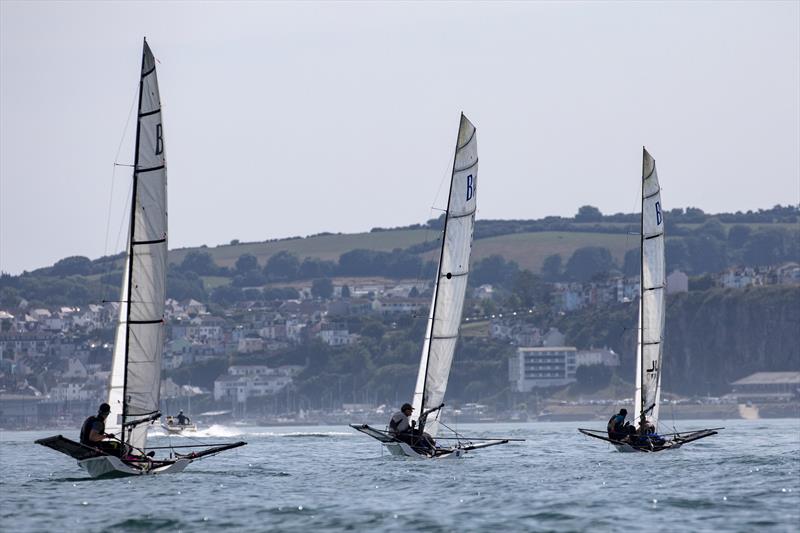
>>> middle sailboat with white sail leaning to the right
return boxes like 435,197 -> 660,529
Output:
350,113 -> 511,458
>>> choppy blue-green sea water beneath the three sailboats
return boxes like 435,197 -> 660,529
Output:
0,420 -> 800,532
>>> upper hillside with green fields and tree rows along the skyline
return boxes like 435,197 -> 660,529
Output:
0,206 -> 800,307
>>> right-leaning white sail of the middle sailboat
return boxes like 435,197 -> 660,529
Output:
413,114 -> 478,437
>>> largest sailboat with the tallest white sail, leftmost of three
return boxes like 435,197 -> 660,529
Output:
36,40 -> 245,477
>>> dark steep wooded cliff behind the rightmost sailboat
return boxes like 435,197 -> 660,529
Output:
554,286 -> 800,395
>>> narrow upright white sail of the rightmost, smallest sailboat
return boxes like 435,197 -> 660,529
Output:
634,149 -> 666,428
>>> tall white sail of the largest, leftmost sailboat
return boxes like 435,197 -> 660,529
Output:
107,41 -> 167,449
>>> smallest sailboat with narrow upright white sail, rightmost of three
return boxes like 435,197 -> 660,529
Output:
578,148 -> 722,452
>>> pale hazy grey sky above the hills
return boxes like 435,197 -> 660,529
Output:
0,0 -> 800,274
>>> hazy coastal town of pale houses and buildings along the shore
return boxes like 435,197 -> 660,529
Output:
0,263 -> 800,428
